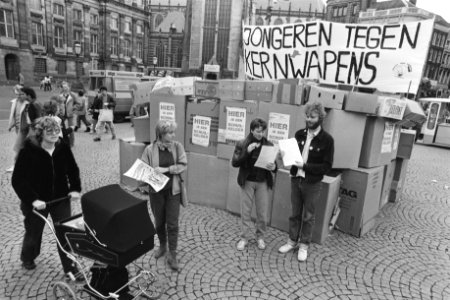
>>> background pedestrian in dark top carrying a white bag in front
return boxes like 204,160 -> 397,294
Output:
92,86 -> 116,142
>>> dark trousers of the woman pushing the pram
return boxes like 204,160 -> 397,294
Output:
20,201 -> 73,273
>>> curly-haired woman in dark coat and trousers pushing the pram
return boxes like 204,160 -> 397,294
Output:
12,116 -> 81,276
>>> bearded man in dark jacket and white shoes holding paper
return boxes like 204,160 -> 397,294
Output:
278,102 -> 334,261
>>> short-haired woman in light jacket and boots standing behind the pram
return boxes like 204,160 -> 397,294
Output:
141,121 -> 187,271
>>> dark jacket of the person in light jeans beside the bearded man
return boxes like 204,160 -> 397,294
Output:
231,133 -> 277,188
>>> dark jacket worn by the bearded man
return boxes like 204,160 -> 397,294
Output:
290,128 -> 334,183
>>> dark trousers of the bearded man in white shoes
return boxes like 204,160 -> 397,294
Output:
289,177 -> 322,245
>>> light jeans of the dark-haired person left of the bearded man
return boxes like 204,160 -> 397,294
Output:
240,181 -> 269,240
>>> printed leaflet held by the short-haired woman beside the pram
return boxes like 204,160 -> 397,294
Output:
123,158 -> 169,192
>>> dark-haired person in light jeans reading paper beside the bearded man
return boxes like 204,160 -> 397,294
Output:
231,118 -> 278,251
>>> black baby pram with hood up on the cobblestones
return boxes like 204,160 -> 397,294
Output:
34,185 -> 163,299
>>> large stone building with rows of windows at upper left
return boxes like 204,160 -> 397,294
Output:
0,0 -> 151,84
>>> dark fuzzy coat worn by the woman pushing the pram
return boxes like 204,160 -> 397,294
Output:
12,138 -> 81,205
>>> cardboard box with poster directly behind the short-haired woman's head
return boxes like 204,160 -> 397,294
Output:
150,93 -> 186,142
